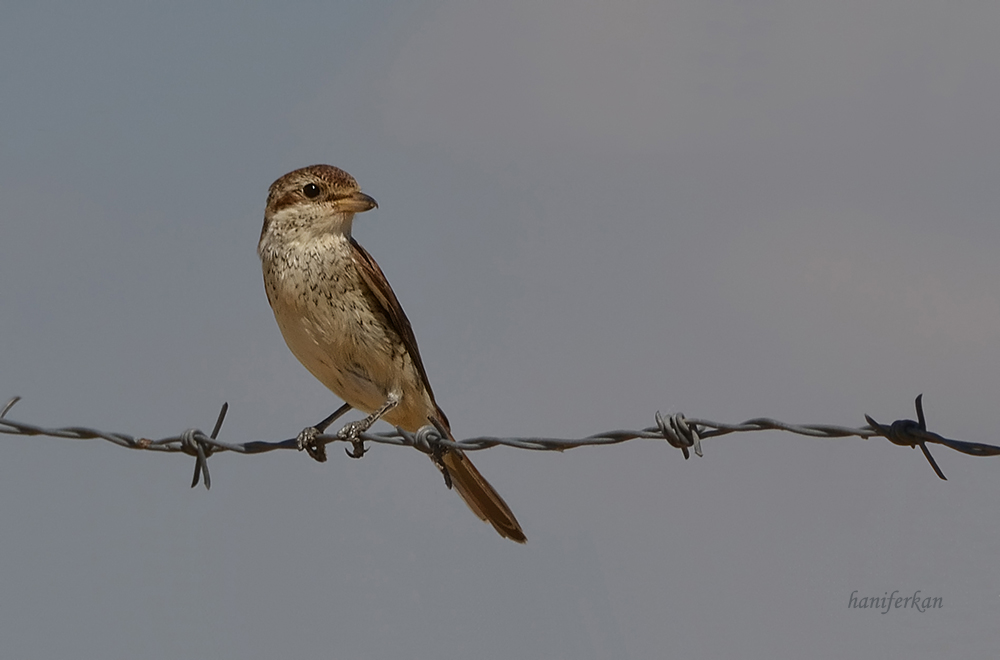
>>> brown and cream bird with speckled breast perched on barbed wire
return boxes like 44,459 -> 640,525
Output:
257,165 -> 527,543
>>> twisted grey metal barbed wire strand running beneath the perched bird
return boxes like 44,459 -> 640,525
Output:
0,394 -> 1000,488
